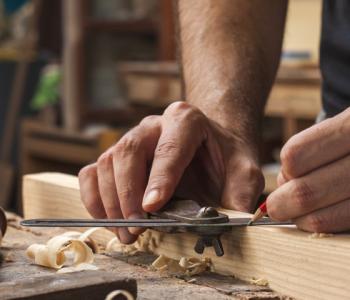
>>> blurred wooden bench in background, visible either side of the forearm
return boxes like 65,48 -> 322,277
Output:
118,62 -> 321,140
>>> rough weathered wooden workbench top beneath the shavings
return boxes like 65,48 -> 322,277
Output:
0,214 -> 290,300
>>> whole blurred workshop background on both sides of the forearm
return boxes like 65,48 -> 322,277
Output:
0,0 -> 322,212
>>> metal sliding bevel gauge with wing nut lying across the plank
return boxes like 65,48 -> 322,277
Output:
21,200 -> 290,256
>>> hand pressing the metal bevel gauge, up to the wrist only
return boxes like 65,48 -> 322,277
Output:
79,102 -> 264,243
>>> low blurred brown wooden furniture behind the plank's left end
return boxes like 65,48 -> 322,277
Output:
17,119 -> 125,210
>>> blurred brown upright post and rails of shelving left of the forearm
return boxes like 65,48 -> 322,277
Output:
63,0 -> 175,130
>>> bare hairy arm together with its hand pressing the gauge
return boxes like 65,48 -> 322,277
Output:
79,0 -> 286,243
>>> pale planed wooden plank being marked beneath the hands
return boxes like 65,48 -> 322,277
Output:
23,173 -> 350,299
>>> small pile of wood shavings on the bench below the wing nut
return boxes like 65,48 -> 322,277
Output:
152,255 -> 212,276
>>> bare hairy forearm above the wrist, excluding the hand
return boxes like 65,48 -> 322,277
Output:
177,0 -> 287,147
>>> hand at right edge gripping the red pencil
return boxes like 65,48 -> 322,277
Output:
267,108 -> 350,232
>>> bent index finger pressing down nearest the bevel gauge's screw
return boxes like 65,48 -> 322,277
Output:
142,102 -> 206,212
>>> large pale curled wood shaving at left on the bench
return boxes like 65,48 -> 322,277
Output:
26,228 -> 97,273
